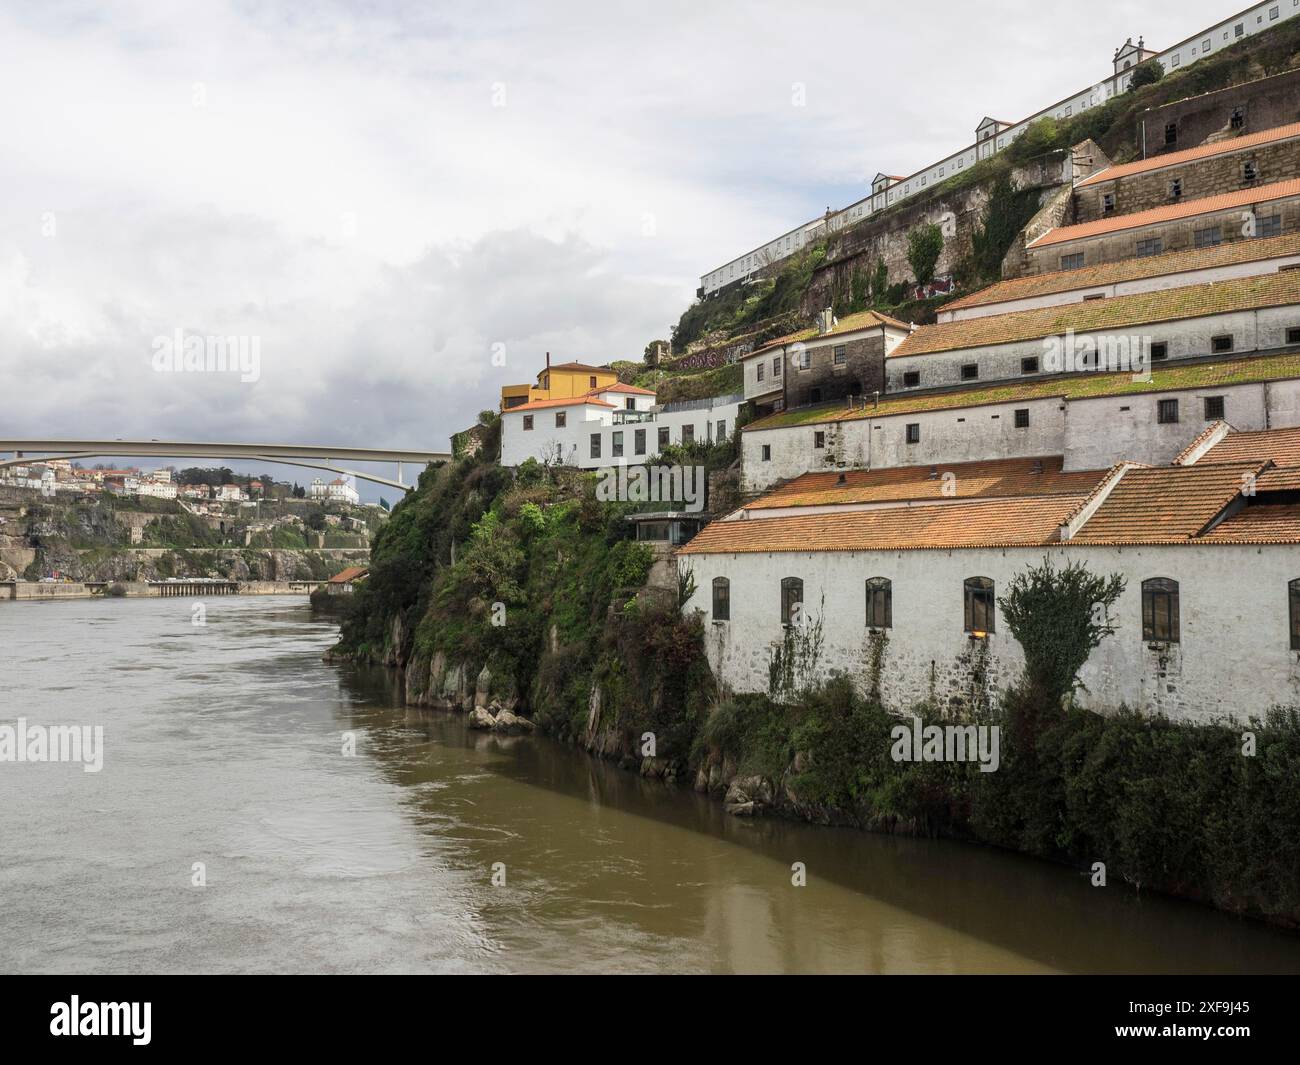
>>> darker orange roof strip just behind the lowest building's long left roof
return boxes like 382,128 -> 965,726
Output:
742,455 -> 1102,511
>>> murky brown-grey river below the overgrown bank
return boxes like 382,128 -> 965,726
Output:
0,597 -> 1300,973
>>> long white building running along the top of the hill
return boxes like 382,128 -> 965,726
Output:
699,0 -> 1300,296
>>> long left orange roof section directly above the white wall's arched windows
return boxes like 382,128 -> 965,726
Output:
677,493 -> 1084,555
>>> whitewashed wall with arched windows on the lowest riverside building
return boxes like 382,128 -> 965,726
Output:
679,545 -> 1300,723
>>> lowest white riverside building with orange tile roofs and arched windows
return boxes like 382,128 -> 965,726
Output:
677,424 -> 1300,722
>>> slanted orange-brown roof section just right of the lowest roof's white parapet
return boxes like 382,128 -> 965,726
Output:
1070,463 -> 1266,544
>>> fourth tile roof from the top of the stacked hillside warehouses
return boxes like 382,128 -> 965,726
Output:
889,269 -> 1300,359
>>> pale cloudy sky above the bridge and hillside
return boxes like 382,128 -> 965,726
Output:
0,0 -> 1236,496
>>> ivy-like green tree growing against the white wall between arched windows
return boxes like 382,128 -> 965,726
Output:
997,557 -> 1125,710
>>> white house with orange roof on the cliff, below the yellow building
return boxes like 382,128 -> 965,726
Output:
501,384 -> 744,469
